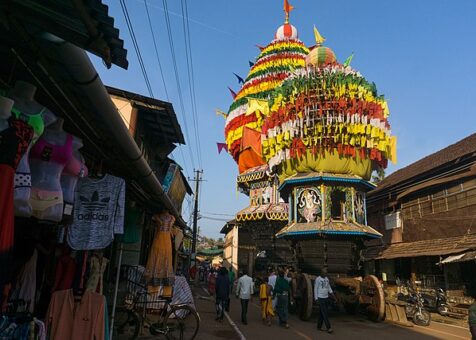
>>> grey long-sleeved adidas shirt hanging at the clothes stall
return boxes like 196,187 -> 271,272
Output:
68,175 -> 126,250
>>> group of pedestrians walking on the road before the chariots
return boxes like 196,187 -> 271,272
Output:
214,267 -> 336,333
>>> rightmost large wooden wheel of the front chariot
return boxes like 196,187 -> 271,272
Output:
360,275 -> 385,321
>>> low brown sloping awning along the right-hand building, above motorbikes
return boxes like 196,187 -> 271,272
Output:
363,234 -> 476,261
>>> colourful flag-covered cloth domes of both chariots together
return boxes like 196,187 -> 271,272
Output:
221,17 -> 397,181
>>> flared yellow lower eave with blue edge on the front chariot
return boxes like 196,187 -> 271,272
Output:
276,221 -> 382,238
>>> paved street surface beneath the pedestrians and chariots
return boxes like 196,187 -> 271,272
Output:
193,287 -> 471,340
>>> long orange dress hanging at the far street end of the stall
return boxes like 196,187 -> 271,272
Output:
145,212 -> 175,296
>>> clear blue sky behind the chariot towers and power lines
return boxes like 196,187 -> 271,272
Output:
92,0 -> 476,237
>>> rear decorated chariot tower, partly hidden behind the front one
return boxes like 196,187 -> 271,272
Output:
225,3 -> 309,276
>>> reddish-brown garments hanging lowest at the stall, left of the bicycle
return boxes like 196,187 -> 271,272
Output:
45,289 -> 106,340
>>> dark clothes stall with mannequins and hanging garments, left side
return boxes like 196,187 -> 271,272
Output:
0,1 -> 192,339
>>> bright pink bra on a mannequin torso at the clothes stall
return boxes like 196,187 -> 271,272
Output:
30,134 -> 73,166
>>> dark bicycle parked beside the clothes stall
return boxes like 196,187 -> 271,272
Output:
113,266 -> 200,340
